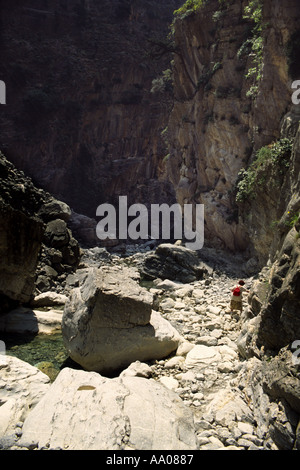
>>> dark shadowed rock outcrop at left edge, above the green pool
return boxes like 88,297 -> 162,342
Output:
0,153 -> 80,312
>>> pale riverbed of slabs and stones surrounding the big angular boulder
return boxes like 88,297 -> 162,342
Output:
0,246 -> 299,450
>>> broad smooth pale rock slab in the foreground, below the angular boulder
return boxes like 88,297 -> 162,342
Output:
18,368 -> 197,450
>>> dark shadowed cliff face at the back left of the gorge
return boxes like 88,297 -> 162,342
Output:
0,0 -> 180,217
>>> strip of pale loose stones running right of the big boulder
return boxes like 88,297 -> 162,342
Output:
79,245 -> 265,450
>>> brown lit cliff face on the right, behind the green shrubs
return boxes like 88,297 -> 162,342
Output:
167,0 -> 299,265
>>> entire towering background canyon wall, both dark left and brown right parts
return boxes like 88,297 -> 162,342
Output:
0,0 -> 300,258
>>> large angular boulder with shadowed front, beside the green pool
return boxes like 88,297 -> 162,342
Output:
62,267 -> 181,373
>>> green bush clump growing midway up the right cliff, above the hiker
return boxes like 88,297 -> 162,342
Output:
236,138 -> 292,202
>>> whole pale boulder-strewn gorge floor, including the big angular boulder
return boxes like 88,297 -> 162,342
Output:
0,245 -> 299,450
